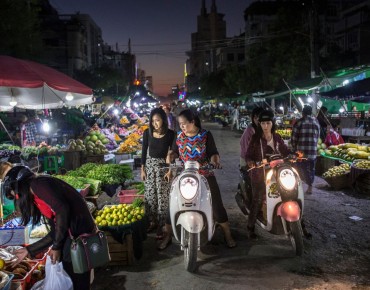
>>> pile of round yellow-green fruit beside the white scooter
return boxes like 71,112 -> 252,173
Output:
95,203 -> 145,227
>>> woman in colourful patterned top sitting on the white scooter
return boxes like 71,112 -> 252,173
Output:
162,109 -> 236,250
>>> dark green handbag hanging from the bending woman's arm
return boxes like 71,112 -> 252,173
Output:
69,229 -> 110,274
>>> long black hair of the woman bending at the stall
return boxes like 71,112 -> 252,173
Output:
14,176 -> 42,225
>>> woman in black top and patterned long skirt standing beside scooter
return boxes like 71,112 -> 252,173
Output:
141,108 -> 175,238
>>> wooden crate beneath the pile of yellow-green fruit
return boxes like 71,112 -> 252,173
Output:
105,232 -> 134,266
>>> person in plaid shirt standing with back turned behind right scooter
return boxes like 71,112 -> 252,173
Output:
291,105 -> 320,194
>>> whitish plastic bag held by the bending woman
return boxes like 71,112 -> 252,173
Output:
31,256 -> 73,290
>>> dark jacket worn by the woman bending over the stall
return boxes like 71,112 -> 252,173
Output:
27,176 -> 96,257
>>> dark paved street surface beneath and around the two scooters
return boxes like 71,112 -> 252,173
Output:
92,123 -> 370,290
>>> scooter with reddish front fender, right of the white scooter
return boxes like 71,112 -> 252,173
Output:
235,155 -> 304,256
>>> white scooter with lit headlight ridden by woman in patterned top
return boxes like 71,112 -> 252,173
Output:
170,161 -> 215,272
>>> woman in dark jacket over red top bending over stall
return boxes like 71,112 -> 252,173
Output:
3,166 -> 96,290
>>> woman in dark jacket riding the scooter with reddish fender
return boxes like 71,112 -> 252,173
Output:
246,110 -> 290,239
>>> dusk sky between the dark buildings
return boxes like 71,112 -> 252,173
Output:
50,0 -> 253,96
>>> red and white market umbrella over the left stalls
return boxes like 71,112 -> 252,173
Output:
0,55 -> 93,111
